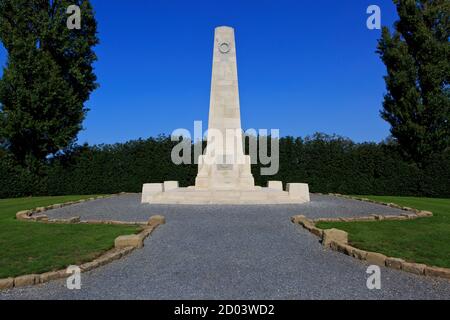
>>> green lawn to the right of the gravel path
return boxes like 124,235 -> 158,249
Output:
317,196 -> 450,268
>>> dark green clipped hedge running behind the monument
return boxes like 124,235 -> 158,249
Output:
0,134 -> 450,198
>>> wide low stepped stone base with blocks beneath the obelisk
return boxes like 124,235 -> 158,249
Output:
142,182 -> 310,205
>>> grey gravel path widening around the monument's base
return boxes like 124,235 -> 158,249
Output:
0,195 -> 450,299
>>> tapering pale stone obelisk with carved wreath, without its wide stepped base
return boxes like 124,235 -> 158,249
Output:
195,27 -> 254,190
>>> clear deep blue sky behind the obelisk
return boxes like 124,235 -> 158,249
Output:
0,0 -> 396,144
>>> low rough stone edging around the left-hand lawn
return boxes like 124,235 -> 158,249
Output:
0,195 -> 166,291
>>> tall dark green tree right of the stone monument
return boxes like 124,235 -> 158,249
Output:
378,0 -> 450,164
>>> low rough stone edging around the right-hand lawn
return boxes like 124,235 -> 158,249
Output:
291,215 -> 450,279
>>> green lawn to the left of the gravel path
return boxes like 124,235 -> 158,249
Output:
0,196 -> 140,279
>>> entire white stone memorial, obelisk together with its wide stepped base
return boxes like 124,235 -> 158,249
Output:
142,27 -> 310,204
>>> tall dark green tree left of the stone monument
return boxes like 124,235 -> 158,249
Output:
0,0 -> 98,163
